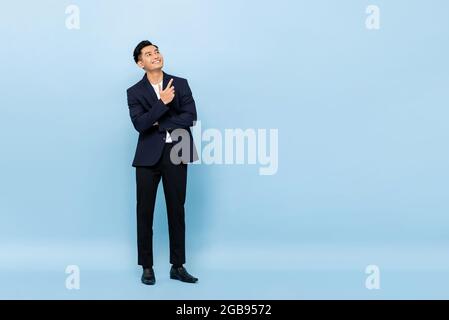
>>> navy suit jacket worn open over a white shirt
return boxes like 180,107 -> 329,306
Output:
127,72 -> 198,167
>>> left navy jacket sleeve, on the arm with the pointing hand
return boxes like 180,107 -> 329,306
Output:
127,89 -> 169,133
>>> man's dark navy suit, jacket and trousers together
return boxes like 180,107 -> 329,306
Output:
127,72 -> 198,268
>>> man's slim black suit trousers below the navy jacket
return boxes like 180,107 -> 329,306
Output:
136,143 -> 187,267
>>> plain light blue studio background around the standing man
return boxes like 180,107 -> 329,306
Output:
0,0 -> 449,299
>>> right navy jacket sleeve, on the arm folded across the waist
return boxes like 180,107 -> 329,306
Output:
159,80 -> 197,131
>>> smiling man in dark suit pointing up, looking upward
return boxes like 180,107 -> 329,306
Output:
127,40 -> 198,285
